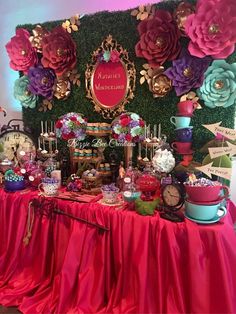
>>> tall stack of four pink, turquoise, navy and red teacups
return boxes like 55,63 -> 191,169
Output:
170,100 -> 194,155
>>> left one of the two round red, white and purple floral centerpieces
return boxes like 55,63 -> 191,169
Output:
55,112 -> 87,141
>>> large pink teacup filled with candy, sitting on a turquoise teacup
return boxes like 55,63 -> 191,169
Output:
184,178 -> 229,203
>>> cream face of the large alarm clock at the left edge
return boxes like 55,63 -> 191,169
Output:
0,131 -> 36,162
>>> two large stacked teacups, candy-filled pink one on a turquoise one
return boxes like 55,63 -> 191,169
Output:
185,178 -> 229,224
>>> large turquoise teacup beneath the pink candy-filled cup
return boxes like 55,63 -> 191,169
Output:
185,201 -> 227,220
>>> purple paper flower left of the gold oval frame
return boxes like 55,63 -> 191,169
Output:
28,66 -> 56,99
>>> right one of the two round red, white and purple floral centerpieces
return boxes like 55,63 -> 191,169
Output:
111,112 -> 145,143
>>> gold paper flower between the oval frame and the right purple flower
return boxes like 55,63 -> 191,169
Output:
149,67 -> 172,98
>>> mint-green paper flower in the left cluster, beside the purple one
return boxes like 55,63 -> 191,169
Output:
14,76 -> 38,108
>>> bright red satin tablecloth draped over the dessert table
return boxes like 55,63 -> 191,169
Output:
0,189 -> 236,314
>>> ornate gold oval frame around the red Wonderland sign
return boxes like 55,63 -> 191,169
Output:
85,35 -> 136,119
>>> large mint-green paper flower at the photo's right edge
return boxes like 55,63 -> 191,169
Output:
197,60 -> 236,108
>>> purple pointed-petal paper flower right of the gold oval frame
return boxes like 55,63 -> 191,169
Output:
165,50 -> 211,96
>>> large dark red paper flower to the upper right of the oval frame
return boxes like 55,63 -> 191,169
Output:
135,10 -> 180,68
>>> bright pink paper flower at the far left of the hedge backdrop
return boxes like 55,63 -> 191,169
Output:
6,28 -> 38,74
